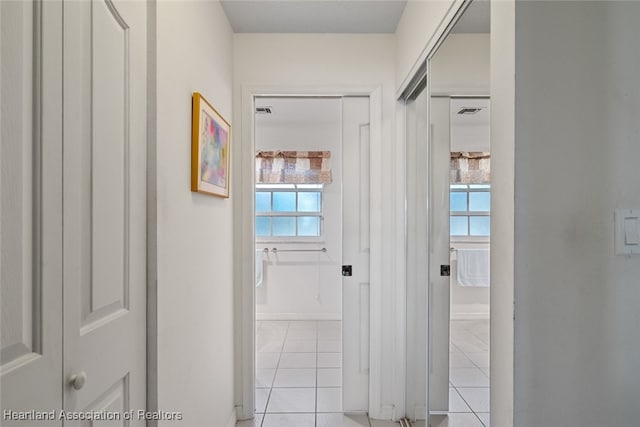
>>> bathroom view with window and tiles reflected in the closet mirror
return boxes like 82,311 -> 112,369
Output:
440,97 -> 491,426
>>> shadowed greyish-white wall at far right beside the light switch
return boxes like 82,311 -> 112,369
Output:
516,2 -> 640,427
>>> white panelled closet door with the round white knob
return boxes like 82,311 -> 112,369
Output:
63,0 -> 147,425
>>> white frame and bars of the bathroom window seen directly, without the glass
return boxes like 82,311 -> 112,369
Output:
254,184 -> 325,243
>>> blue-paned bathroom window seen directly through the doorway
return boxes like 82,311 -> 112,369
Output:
256,184 -> 322,239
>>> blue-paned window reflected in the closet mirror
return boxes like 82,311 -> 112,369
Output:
449,184 -> 491,237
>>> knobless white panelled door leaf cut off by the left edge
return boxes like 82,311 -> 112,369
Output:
0,1 -> 62,427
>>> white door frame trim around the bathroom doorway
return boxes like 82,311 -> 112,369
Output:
232,85 -> 383,420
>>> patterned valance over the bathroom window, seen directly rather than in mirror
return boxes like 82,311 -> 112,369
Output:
256,151 -> 331,184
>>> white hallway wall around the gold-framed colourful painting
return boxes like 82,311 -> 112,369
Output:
155,1 -> 235,427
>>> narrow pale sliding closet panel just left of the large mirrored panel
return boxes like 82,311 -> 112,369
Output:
405,84 -> 430,420
